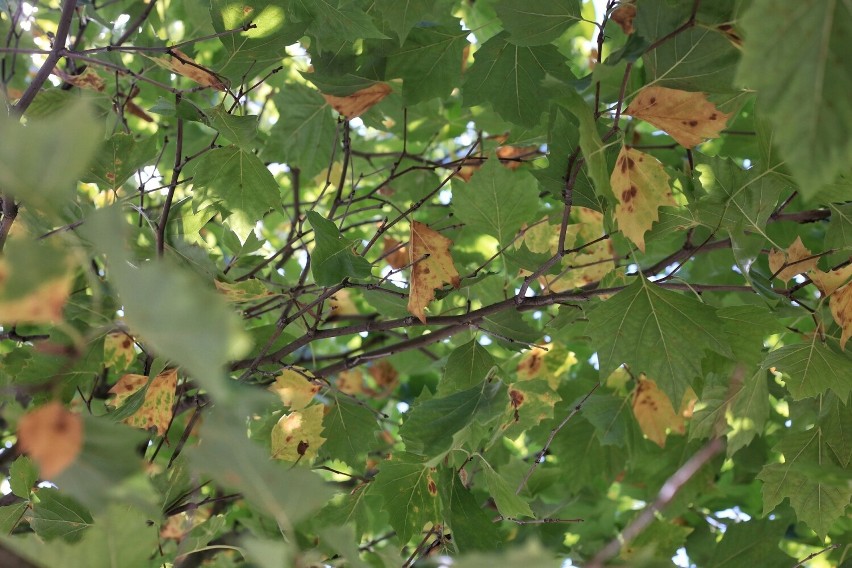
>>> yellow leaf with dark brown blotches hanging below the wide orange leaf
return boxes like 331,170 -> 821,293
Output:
610,146 -> 677,252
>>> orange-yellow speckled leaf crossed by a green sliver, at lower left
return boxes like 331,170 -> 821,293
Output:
109,369 -> 177,436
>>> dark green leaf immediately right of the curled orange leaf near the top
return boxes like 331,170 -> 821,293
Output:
387,24 -> 468,105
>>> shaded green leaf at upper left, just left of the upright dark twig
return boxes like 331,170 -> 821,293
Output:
82,132 -> 158,190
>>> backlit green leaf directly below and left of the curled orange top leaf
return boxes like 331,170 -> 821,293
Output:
263,84 -> 336,178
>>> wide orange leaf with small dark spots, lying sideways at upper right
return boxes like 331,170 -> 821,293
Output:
624,86 -> 731,148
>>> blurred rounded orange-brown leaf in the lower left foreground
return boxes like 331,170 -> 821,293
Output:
18,401 -> 83,479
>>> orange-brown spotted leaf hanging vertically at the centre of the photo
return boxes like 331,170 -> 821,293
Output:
408,221 -> 461,323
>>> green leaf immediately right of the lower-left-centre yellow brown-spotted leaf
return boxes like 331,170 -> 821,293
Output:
320,397 -> 379,468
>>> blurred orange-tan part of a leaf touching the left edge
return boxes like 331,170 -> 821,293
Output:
0,258 -> 73,325
